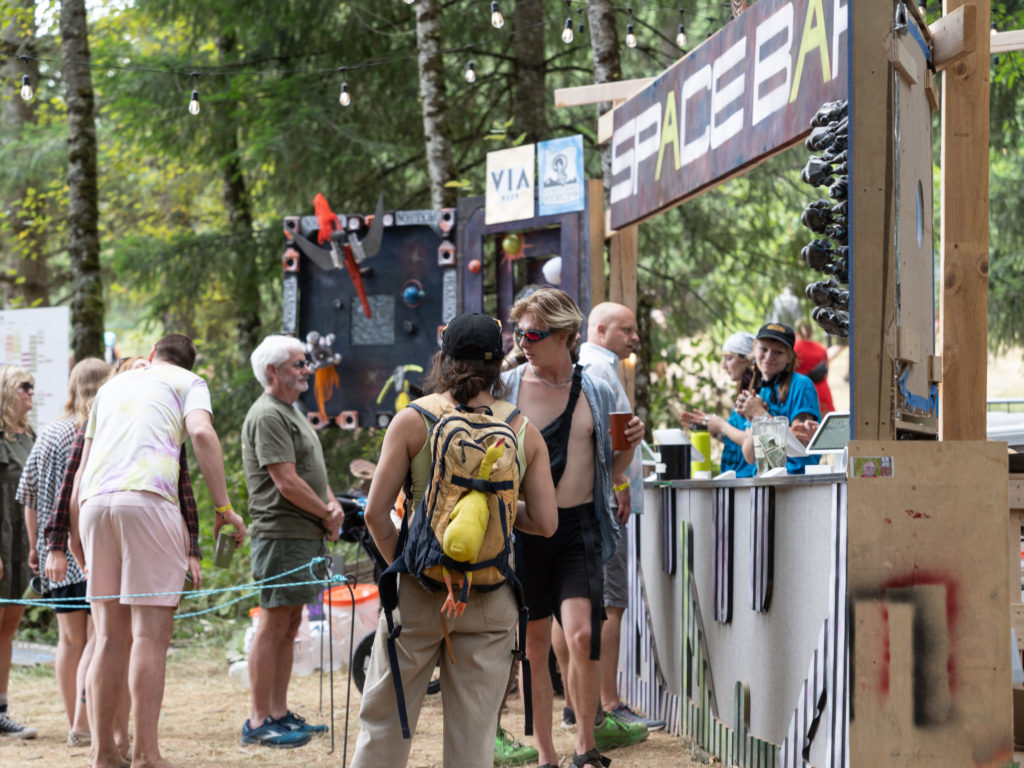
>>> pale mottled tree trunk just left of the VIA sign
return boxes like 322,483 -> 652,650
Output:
416,0 -> 459,208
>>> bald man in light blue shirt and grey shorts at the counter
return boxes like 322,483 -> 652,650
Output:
552,301 -> 665,730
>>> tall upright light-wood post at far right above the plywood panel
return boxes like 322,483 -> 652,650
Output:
933,0 -> 990,440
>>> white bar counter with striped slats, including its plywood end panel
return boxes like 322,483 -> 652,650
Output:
620,442 -> 1013,768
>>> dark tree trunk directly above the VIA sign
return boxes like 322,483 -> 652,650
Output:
513,0 -> 549,143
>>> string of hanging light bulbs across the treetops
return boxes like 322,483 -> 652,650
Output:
9,0 -> 720,116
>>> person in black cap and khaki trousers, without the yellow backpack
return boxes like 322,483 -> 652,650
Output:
352,313 -> 557,768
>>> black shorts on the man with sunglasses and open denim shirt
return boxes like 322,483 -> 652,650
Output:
518,503 -> 604,621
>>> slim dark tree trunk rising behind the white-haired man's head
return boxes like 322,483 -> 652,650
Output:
214,30 -> 261,360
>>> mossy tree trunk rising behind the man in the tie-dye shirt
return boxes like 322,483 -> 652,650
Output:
60,0 -> 103,360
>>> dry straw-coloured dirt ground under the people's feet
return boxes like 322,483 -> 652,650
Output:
0,649 -> 701,768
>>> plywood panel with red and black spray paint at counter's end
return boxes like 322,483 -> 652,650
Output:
848,440 -> 1013,768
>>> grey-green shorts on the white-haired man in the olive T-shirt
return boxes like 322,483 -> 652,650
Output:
250,537 -> 328,608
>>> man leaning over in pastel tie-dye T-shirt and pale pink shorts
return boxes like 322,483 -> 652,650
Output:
73,334 -> 246,768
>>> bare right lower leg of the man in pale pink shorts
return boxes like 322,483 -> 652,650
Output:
129,605 -> 174,768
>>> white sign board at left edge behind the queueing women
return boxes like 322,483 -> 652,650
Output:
0,307 -> 71,434
